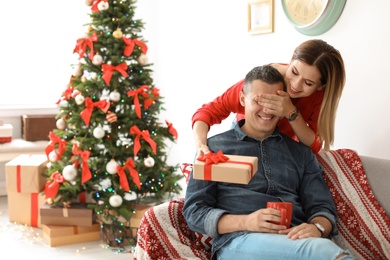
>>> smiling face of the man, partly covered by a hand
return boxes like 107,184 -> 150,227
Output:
240,80 -> 283,140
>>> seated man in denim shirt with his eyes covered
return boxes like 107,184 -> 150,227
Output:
183,66 -> 353,260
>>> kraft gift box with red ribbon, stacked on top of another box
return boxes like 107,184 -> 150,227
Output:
5,154 -> 48,193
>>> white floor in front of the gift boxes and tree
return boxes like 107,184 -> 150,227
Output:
0,196 -> 133,260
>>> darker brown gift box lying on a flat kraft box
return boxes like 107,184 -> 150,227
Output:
40,203 -> 95,226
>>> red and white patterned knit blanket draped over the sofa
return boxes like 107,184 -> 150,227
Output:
134,149 -> 390,260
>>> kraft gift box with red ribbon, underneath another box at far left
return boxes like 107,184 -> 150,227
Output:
7,192 -> 45,227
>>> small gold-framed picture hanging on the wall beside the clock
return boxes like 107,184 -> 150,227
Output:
248,0 -> 274,34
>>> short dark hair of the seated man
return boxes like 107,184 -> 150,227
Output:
243,65 -> 286,94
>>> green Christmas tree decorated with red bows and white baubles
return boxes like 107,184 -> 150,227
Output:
45,0 -> 182,244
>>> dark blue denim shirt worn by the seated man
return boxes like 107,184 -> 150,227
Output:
183,120 -> 338,255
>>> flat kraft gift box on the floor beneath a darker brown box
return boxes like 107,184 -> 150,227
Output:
42,223 -> 100,246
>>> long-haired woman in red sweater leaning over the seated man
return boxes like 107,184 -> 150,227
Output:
192,39 -> 345,155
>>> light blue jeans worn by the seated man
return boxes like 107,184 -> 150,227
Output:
216,233 -> 354,260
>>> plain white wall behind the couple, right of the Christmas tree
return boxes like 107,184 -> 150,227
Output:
132,0 -> 390,167
